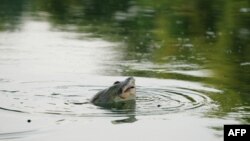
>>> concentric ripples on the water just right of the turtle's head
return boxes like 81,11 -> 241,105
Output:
137,87 -> 211,115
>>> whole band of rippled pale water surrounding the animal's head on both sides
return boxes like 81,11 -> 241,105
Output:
0,77 -> 215,117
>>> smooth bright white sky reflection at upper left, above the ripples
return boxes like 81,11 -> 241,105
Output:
0,20 -> 119,75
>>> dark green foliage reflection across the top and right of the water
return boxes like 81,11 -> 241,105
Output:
0,0 -> 250,122
